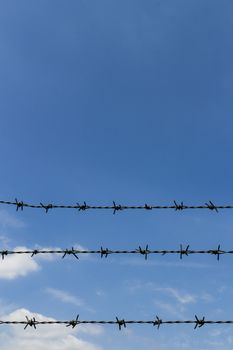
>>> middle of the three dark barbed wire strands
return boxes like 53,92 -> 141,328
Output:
0,244 -> 229,260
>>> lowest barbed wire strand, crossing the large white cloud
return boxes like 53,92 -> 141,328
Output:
0,315 -> 233,330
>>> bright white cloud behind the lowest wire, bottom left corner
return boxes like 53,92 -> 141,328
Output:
0,309 -> 101,350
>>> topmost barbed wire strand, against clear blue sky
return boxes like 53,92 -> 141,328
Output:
0,198 -> 233,214
